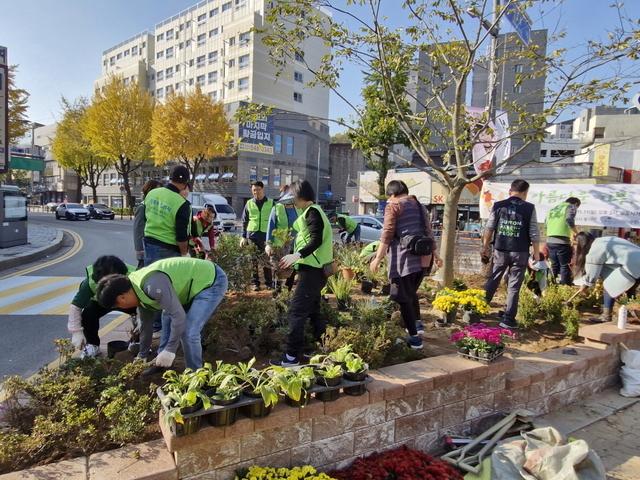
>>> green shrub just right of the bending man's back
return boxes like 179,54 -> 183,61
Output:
210,235 -> 260,292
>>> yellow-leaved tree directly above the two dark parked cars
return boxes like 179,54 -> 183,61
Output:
51,97 -> 111,202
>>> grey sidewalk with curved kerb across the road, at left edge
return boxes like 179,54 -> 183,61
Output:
0,224 -> 63,270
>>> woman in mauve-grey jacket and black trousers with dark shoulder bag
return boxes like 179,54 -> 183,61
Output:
370,180 -> 442,350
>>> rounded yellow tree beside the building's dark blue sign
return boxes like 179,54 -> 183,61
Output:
151,87 -> 233,186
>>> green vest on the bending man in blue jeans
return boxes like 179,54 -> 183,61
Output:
129,257 -> 216,310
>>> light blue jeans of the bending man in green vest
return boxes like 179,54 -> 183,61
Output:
158,265 -> 229,369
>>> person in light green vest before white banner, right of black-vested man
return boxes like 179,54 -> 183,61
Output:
545,197 -> 580,285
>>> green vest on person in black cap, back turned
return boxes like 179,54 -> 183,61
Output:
144,187 -> 191,245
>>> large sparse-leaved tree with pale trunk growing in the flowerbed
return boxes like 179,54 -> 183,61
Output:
260,0 -> 640,285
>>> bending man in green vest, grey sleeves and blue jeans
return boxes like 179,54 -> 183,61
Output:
97,257 -> 228,374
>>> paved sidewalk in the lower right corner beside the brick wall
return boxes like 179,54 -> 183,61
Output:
535,389 -> 640,480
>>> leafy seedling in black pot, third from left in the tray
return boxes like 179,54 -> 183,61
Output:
232,358 -> 280,418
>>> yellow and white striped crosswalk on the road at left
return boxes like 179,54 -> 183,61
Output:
0,275 -> 84,315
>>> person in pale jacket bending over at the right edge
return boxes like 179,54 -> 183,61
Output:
570,232 -> 640,323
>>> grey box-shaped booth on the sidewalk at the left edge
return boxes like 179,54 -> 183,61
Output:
0,185 -> 27,248
